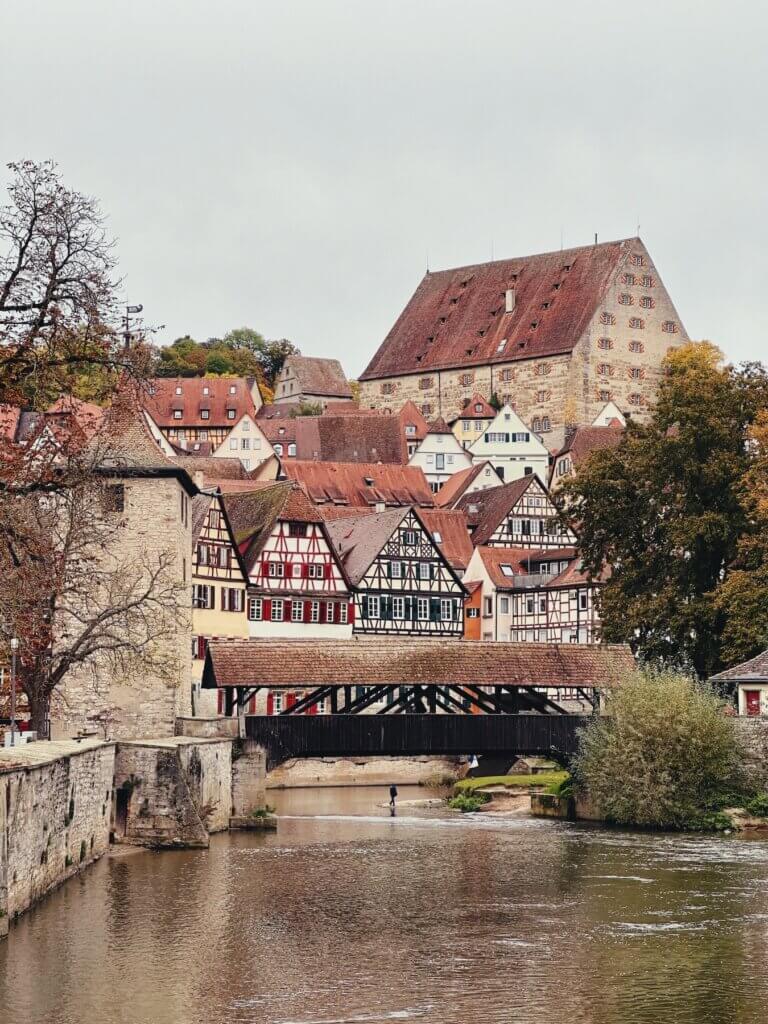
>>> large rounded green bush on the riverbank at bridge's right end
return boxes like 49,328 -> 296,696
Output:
573,671 -> 739,828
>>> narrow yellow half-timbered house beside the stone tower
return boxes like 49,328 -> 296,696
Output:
190,490 -> 248,715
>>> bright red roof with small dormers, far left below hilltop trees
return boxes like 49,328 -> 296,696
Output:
141,377 -> 256,429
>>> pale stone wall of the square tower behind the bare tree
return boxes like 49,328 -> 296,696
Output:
51,478 -> 191,738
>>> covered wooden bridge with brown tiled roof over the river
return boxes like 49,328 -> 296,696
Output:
203,638 -> 634,763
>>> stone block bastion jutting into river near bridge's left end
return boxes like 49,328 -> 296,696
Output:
115,736 -> 232,847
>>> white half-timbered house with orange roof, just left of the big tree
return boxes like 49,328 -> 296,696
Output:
465,547 -> 600,643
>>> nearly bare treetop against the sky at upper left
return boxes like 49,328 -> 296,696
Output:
0,160 -> 146,409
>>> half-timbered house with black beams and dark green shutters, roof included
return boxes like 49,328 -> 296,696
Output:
328,508 -> 465,638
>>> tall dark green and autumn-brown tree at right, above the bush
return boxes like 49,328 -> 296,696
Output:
560,343 -> 765,676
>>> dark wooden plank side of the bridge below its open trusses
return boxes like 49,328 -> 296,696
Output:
246,715 -> 589,764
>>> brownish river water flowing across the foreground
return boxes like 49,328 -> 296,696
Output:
0,786 -> 768,1024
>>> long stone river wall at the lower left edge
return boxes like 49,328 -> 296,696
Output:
0,740 -> 115,919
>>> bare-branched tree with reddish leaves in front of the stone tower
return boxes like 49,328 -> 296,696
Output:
0,447 -> 185,735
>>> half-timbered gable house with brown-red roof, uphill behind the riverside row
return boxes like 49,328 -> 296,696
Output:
456,475 -> 575,548
